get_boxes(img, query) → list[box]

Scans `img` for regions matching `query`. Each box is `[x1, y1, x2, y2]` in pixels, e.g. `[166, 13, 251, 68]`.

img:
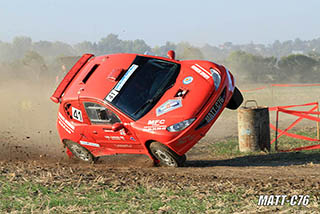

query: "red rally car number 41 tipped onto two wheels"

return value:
[51, 51, 243, 166]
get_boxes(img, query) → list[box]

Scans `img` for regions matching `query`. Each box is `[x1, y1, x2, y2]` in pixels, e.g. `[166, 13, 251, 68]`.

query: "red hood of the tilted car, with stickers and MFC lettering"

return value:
[140, 61, 222, 125]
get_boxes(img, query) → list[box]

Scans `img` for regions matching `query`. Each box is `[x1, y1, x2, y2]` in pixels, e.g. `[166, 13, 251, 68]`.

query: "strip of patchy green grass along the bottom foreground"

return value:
[0, 177, 246, 213]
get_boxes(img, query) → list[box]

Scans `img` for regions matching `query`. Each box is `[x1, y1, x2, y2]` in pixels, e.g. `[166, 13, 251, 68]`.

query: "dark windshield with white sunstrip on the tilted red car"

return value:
[105, 56, 180, 120]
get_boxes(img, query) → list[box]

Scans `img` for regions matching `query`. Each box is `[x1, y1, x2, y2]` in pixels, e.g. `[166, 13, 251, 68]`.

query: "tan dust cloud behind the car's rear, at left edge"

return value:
[0, 76, 64, 159]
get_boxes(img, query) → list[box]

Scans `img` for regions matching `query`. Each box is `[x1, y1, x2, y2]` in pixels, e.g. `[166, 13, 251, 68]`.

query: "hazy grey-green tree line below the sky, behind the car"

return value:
[0, 34, 320, 83]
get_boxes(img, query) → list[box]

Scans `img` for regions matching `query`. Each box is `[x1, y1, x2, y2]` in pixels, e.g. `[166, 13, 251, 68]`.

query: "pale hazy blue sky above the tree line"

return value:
[0, 0, 320, 46]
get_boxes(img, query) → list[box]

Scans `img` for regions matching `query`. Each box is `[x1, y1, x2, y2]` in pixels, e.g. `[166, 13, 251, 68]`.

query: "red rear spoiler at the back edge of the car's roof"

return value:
[50, 54, 94, 103]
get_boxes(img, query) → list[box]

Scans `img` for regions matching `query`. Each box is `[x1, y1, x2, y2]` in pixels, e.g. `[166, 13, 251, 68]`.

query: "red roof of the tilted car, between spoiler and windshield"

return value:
[63, 54, 177, 100]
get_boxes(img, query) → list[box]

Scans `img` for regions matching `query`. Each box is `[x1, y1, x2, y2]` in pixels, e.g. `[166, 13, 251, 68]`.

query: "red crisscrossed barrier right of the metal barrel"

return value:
[269, 102, 320, 152]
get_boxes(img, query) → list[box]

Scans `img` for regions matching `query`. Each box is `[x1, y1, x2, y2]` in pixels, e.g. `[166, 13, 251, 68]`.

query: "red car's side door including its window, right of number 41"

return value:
[83, 101, 142, 153]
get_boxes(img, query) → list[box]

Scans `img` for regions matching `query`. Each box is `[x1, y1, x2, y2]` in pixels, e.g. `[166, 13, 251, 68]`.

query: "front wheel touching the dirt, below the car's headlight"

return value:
[150, 142, 186, 167]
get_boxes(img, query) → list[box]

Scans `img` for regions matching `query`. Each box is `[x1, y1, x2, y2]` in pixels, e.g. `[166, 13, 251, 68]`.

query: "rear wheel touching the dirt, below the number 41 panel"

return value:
[65, 140, 98, 162]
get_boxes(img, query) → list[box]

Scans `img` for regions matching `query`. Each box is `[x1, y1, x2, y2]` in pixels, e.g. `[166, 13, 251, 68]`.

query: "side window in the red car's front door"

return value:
[84, 102, 121, 124]
